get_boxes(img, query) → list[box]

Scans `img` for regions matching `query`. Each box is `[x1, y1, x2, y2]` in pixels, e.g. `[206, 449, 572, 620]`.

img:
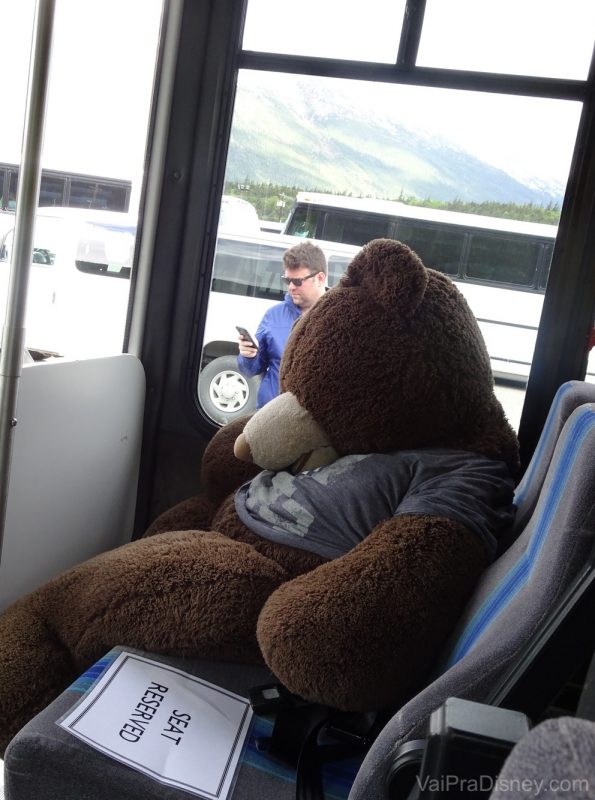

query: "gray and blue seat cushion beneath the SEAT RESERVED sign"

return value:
[4, 648, 359, 800]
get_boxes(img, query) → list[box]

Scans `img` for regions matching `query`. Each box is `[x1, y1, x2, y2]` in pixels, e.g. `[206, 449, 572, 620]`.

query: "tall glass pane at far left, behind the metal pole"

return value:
[0, 0, 164, 359]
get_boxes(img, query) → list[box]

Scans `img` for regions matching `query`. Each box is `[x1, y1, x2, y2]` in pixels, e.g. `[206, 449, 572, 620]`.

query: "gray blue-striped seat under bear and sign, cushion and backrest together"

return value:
[5, 396, 595, 800]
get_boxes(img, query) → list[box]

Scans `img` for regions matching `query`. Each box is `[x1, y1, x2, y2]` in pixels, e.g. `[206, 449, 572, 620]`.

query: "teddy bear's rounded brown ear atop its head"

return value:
[341, 239, 428, 319]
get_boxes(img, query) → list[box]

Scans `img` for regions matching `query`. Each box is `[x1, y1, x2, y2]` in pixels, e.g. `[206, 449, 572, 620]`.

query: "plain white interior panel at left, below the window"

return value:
[0, 354, 145, 609]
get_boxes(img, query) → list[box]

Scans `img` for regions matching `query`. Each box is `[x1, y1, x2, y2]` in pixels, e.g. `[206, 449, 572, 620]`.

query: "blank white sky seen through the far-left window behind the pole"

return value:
[0, 0, 162, 178]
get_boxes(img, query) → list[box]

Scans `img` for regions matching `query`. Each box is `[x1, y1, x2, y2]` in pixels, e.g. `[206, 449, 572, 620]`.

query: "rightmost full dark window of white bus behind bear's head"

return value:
[465, 233, 541, 287]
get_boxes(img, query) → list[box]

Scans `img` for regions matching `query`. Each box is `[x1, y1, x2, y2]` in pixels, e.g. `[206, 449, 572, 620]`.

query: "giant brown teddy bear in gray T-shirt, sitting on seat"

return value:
[0, 239, 518, 749]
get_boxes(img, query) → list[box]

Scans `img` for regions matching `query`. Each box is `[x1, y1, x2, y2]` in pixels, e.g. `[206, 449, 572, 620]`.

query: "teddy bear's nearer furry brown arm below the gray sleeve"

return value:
[257, 515, 486, 711]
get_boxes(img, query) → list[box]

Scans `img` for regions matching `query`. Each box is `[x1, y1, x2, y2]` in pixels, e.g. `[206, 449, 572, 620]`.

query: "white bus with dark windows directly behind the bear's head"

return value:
[285, 192, 557, 382]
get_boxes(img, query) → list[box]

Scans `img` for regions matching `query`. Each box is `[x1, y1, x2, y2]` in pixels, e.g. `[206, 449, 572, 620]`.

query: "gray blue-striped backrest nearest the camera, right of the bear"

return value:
[349, 398, 595, 800]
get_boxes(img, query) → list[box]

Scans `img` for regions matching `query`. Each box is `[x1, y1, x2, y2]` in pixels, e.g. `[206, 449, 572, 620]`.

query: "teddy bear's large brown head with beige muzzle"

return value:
[236, 239, 518, 470]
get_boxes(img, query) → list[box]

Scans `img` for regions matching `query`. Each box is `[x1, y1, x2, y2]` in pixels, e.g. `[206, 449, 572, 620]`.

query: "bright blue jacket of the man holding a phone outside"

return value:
[238, 292, 301, 408]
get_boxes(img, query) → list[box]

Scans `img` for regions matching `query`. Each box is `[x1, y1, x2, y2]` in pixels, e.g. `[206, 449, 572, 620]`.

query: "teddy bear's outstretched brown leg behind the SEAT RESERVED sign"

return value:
[0, 531, 287, 749]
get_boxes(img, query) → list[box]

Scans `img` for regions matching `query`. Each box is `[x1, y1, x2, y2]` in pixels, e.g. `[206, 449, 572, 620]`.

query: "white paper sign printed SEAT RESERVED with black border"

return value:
[58, 652, 252, 800]
